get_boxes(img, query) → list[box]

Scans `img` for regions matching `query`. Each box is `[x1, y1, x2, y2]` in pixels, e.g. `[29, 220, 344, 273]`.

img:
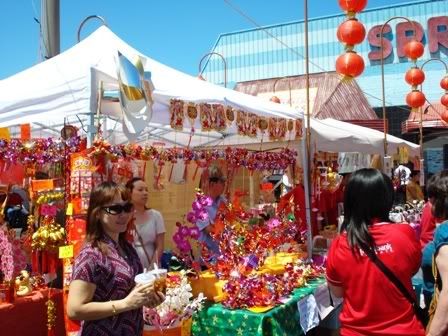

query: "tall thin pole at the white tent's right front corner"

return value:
[303, 0, 313, 261]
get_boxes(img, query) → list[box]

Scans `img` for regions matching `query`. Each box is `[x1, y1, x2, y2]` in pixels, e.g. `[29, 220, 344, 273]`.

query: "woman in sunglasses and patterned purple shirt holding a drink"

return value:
[67, 182, 164, 336]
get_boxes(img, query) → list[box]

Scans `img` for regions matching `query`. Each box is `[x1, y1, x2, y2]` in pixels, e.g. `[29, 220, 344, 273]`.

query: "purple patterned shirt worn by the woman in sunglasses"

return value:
[72, 235, 143, 336]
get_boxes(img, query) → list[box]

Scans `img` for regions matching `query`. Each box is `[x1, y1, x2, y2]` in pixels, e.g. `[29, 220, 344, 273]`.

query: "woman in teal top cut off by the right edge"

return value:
[423, 170, 448, 336]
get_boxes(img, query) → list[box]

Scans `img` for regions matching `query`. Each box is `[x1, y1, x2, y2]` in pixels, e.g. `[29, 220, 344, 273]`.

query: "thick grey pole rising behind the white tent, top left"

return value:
[40, 0, 60, 59]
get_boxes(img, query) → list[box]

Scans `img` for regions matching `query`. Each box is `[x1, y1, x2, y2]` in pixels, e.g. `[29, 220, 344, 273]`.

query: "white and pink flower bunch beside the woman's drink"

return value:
[143, 271, 205, 330]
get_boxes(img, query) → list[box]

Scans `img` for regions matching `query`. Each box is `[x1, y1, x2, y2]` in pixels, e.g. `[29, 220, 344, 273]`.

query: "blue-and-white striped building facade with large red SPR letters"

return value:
[203, 0, 448, 115]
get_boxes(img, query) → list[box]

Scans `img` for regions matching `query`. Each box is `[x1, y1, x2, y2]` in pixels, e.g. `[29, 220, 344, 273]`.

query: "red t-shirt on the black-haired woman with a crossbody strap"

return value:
[327, 223, 425, 336]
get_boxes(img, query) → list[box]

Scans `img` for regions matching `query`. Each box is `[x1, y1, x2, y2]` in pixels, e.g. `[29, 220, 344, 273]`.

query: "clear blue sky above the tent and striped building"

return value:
[0, 0, 409, 79]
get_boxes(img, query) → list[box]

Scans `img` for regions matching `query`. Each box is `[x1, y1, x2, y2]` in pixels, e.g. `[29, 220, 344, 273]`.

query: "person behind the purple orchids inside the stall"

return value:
[196, 166, 227, 256]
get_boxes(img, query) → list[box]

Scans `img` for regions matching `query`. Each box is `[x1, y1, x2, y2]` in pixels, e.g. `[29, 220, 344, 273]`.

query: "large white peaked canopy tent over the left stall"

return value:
[0, 26, 303, 146]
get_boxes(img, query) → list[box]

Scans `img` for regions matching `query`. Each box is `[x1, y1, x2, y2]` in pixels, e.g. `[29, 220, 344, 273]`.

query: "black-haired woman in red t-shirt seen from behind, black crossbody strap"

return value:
[327, 168, 424, 336]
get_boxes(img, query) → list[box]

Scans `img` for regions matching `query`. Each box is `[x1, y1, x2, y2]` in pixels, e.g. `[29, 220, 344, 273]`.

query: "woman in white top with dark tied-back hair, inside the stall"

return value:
[126, 177, 165, 269]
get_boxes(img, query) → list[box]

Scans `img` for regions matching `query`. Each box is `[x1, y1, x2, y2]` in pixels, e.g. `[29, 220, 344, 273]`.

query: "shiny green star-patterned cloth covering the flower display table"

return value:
[192, 279, 325, 336]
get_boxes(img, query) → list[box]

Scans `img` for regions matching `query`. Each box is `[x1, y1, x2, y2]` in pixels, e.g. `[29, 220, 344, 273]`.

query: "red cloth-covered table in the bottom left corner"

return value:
[0, 289, 65, 336]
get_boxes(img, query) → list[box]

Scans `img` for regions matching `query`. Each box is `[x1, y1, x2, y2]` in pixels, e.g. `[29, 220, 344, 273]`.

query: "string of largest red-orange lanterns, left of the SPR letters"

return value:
[336, 0, 367, 80]
